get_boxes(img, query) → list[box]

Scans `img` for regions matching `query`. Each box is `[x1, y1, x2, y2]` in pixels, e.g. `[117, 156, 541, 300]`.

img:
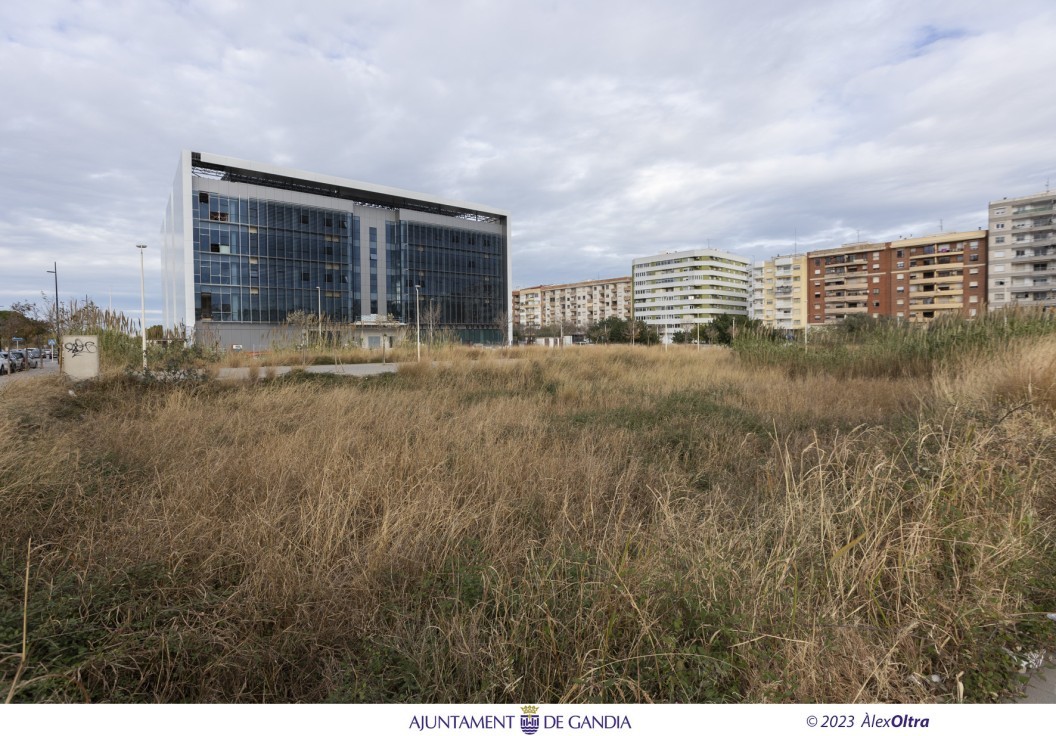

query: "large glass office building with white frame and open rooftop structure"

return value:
[162, 151, 511, 350]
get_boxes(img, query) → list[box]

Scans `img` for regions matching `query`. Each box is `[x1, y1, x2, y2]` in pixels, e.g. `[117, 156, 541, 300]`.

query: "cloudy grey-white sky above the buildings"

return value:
[0, 0, 1056, 323]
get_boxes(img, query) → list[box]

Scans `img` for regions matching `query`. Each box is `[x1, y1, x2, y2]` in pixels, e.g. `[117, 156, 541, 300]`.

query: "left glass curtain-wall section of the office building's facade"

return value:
[191, 190, 359, 322]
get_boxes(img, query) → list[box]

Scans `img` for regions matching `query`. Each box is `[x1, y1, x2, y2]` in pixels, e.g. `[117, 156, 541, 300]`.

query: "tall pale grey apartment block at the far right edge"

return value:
[987, 192, 1056, 309]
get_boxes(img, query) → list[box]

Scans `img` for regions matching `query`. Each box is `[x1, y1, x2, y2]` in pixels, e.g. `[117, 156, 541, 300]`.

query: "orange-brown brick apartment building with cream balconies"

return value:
[807, 230, 987, 326]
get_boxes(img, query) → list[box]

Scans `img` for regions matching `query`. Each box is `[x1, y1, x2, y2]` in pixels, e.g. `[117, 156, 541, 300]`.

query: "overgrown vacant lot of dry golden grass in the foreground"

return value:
[0, 338, 1056, 702]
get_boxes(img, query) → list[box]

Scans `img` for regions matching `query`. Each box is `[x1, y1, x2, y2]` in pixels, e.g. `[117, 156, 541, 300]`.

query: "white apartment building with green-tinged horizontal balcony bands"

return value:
[631, 248, 752, 340]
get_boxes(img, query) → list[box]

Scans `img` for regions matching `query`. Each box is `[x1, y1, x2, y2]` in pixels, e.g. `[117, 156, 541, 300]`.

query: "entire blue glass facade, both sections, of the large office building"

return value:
[191, 189, 508, 342]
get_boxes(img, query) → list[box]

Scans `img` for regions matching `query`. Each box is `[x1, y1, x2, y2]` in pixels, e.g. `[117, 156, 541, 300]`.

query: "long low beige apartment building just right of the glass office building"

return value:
[513, 276, 631, 332]
